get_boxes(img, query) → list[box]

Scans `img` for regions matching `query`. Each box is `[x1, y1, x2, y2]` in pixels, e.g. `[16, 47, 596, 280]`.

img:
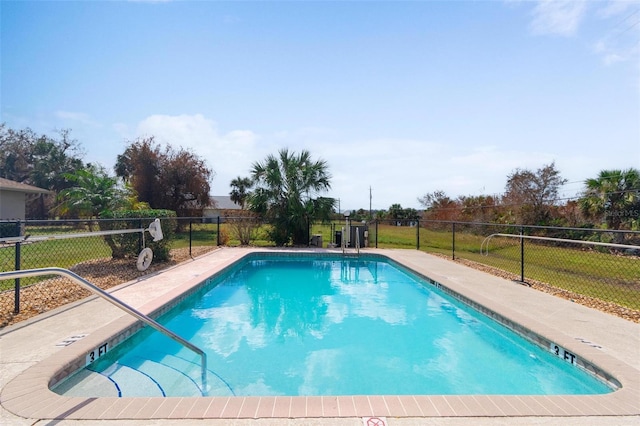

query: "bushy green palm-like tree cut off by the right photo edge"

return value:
[580, 168, 640, 233]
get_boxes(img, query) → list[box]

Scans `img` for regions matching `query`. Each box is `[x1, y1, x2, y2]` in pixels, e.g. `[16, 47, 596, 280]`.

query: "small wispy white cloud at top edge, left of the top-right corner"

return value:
[531, 0, 587, 36]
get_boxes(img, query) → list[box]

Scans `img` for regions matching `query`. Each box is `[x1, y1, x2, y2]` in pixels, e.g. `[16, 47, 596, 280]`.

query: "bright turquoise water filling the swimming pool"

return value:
[54, 256, 611, 396]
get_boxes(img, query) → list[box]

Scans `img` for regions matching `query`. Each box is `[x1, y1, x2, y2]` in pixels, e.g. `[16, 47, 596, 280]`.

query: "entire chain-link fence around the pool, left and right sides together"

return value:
[0, 217, 640, 328]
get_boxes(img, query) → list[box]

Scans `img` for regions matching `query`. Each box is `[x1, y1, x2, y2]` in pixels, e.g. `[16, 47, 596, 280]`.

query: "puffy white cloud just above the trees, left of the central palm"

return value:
[136, 114, 263, 195]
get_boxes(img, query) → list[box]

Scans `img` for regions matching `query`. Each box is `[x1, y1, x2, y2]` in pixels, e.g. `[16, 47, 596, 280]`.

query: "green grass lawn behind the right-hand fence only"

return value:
[378, 225, 640, 310]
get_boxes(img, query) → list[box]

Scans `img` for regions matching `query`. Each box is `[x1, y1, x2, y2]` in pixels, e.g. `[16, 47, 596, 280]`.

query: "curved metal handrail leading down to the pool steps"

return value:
[0, 267, 207, 392]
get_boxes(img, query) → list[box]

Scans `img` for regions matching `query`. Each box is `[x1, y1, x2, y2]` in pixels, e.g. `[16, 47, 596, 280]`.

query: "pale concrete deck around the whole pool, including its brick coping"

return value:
[0, 248, 640, 426]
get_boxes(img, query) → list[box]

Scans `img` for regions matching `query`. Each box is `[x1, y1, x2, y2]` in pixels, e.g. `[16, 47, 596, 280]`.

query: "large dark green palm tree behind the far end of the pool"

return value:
[249, 148, 335, 246]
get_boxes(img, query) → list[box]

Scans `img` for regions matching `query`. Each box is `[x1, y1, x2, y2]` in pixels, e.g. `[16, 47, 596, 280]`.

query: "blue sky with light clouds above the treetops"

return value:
[0, 0, 640, 209]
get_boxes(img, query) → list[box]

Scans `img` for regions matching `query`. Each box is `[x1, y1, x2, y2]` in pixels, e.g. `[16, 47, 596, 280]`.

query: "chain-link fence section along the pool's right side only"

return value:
[370, 221, 640, 322]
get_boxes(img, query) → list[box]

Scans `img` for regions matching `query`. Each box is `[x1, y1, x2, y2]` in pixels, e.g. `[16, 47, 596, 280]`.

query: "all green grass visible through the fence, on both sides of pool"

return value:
[0, 222, 640, 310]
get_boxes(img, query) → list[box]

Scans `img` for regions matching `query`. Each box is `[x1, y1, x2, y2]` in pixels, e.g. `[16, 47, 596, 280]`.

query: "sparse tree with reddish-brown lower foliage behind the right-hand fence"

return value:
[504, 163, 567, 225]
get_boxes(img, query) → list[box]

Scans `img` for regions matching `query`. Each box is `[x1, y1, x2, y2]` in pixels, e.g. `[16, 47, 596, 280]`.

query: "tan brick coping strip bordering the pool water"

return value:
[0, 249, 640, 420]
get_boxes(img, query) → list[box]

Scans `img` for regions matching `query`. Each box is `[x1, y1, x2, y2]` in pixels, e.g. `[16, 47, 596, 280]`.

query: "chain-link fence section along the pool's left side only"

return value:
[0, 218, 220, 328]
